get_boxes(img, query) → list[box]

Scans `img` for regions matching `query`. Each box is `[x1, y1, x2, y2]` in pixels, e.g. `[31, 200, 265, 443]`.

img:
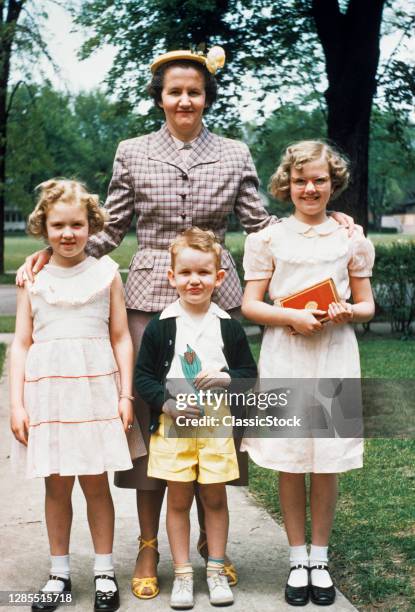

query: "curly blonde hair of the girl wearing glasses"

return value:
[268, 140, 350, 202]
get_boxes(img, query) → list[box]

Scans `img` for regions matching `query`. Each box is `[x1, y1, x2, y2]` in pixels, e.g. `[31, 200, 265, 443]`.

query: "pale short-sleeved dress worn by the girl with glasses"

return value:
[241, 216, 374, 473]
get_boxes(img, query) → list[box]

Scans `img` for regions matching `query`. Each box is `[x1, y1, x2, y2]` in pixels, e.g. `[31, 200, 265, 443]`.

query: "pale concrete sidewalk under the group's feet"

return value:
[0, 344, 356, 612]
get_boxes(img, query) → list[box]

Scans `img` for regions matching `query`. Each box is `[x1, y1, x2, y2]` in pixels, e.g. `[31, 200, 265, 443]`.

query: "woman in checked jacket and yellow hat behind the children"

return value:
[18, 47, 353, 599]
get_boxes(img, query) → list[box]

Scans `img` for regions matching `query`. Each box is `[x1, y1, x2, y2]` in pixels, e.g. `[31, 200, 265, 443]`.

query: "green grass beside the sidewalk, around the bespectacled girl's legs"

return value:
[250, 337, 415, 612]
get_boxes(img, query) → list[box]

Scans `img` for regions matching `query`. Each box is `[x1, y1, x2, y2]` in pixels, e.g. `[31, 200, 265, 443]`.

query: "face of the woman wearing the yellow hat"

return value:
[160, 66, 210, 140]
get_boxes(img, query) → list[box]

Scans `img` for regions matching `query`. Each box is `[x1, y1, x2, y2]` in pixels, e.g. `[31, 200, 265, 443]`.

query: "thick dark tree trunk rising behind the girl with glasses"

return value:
[312, 0, 385, 231]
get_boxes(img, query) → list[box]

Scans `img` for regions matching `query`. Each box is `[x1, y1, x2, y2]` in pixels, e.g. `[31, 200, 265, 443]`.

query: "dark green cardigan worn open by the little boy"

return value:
[134, 314, 257, 432]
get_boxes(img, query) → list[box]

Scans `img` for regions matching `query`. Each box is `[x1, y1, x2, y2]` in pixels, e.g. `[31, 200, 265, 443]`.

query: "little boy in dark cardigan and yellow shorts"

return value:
[135, 227, 257, 609]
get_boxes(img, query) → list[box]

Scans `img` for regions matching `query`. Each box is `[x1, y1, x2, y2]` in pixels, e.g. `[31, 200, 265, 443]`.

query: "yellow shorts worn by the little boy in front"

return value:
[147, 414, 239, 484]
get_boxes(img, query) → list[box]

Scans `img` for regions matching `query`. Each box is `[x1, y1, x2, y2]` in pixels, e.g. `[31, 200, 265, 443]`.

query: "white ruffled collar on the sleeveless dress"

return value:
[29, 255, 118, 306]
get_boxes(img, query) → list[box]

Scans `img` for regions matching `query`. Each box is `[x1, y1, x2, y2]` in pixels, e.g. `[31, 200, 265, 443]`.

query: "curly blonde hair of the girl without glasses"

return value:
[27, 178, 107, 238]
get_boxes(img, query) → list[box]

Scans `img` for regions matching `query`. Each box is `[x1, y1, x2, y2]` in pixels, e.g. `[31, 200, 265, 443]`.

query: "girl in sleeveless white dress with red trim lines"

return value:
[10, 179, 141, 611]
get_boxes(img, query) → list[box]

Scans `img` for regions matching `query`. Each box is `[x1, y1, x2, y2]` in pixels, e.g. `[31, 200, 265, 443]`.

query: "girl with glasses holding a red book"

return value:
[241, 141, 374, 606]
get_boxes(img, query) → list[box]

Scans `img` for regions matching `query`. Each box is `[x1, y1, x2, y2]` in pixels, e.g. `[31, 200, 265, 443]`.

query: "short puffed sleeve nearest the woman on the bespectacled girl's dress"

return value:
[243, 227, 274, 280]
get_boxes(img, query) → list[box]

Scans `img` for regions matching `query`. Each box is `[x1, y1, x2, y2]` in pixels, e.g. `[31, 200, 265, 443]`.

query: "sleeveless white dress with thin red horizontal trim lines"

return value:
[19, 256, 132, 478]
